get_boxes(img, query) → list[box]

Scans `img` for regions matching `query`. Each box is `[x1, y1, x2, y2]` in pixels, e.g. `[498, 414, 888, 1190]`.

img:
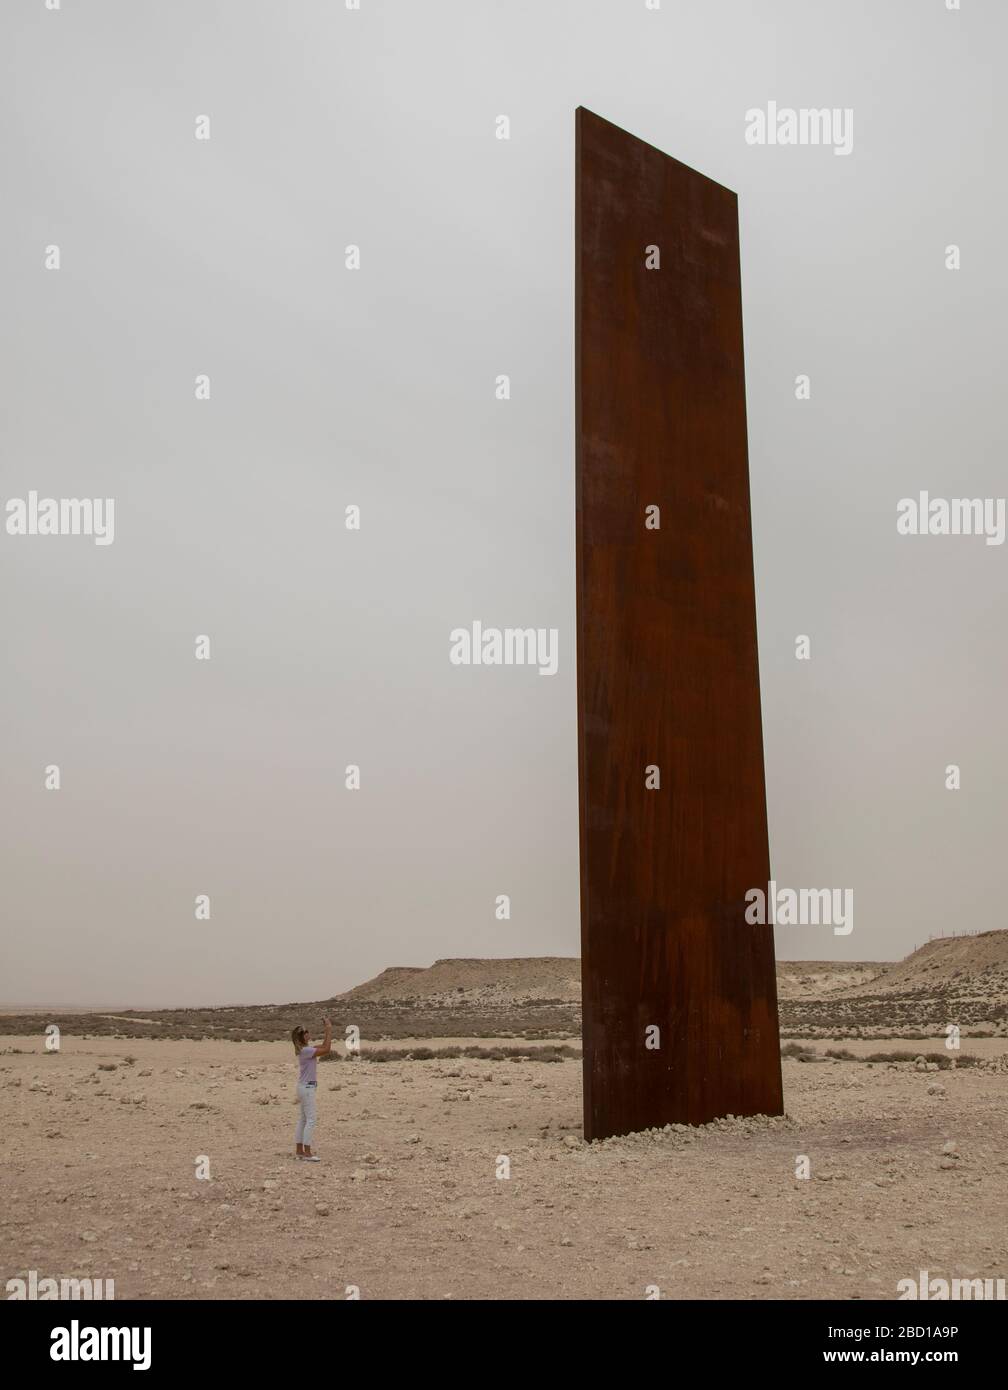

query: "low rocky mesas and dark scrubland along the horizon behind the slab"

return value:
[0, 929, 1008, 1040]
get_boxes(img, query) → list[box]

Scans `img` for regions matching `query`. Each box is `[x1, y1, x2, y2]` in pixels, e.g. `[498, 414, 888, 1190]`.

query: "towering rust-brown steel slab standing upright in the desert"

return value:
[576, 108, 783, 1138]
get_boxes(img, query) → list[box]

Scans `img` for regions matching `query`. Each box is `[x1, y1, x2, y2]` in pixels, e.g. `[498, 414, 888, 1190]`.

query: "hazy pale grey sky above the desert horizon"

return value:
[0, 0, 1008, 1006]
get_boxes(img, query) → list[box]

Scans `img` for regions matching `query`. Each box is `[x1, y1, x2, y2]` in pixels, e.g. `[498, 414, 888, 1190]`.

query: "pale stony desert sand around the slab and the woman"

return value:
[0, 1033, 1008, 1298]
